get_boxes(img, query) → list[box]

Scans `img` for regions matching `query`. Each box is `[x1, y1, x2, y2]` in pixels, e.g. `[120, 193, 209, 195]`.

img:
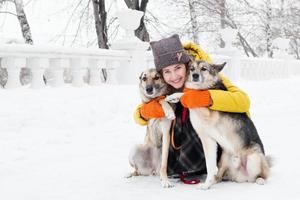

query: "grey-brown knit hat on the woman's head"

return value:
[150, 34, 190, 71]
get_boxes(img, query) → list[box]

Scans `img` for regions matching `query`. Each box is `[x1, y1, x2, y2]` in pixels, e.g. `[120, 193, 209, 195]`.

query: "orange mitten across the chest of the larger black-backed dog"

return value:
[180, 88, 211, 108]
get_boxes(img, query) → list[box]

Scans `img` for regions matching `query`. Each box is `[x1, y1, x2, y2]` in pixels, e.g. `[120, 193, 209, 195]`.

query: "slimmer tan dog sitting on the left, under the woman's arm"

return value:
[128, 69, 175, 187]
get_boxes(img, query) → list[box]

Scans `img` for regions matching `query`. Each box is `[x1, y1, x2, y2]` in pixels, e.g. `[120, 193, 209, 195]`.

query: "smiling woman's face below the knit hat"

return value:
[162, 64, 186, 89]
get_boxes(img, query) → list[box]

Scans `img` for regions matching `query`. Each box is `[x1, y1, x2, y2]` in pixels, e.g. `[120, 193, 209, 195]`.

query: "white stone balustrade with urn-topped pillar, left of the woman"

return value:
[0, 9, 151, 88]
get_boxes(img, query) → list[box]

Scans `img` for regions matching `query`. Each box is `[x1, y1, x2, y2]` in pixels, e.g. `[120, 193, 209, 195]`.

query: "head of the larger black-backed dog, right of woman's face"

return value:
[185, 60, 226, 90]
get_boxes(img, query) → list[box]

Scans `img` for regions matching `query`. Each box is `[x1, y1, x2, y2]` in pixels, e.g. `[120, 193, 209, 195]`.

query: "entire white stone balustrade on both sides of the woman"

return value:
[0, 13, 300, 88]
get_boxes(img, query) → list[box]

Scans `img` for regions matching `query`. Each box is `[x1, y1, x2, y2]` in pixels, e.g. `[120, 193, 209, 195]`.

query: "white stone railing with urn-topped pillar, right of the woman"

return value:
[212, 28, 300, 80]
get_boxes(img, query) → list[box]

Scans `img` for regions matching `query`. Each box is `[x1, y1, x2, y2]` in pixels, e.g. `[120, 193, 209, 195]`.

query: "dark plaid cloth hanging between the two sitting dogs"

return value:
[168, 103, 221, 176]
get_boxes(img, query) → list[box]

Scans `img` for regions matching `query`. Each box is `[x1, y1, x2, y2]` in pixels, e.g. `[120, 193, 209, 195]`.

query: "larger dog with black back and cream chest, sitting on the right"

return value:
[167, 61, 269, 189]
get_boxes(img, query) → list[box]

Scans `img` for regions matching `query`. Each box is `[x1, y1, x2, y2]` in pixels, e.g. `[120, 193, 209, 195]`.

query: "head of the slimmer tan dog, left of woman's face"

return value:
[139, 69, 167, 102]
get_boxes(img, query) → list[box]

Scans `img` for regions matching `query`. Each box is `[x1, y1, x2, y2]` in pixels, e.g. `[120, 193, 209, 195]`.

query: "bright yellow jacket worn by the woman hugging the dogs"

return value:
[134, 42, 250, 125]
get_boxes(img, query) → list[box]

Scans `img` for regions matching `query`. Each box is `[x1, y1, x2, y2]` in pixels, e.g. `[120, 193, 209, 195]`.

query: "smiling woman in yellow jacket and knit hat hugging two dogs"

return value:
[135, 34, 250, 180]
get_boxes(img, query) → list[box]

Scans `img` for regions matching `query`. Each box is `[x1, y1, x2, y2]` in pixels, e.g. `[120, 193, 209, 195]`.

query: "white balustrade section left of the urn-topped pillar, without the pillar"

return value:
[0, 44, 131, 88]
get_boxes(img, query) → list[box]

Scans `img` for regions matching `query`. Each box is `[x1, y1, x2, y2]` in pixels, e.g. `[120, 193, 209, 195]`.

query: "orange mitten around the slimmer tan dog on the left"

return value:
[140, 96, 165, 120]
